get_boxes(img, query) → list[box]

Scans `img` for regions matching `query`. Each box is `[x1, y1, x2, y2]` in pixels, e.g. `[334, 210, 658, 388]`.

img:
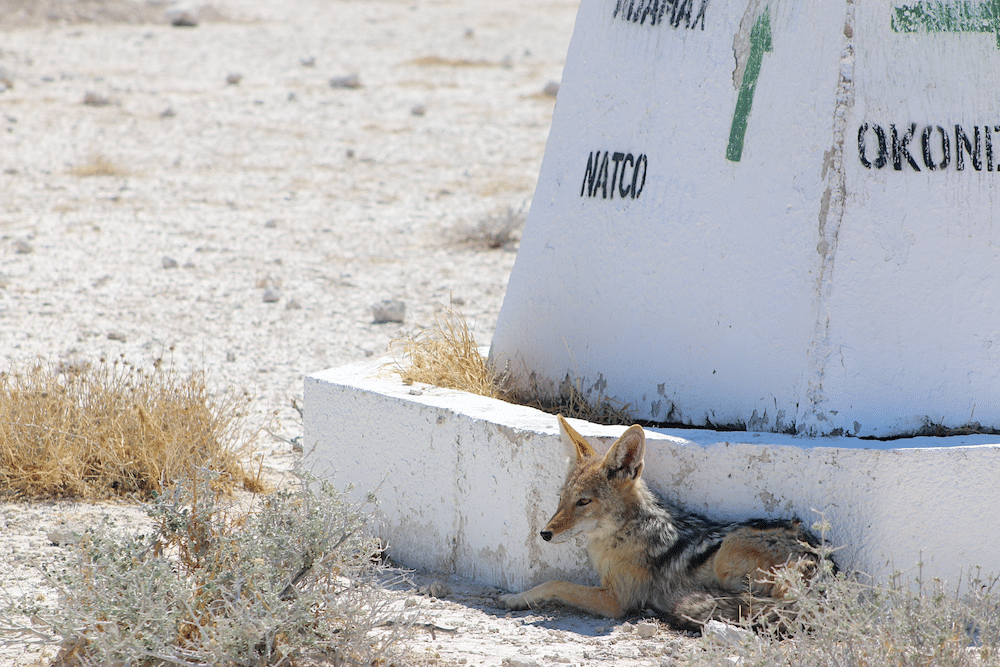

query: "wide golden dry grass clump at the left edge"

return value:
[0, 359, 264, 499]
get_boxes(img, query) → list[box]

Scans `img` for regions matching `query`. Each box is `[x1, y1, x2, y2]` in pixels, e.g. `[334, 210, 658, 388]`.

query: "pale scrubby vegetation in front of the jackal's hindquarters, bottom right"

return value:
[690, 556, 1000, 667]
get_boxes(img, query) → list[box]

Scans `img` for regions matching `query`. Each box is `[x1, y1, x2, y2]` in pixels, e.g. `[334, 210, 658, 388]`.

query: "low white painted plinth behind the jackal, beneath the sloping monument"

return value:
[305, 359, 1000, 590]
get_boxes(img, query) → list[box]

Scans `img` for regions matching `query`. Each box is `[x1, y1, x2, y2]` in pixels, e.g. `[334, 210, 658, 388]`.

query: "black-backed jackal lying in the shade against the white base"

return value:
[500, 415, 833, 630]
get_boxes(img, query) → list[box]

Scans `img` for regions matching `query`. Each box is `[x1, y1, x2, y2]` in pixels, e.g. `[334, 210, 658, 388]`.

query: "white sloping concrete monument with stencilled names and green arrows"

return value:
[491, 0, 1000, 436]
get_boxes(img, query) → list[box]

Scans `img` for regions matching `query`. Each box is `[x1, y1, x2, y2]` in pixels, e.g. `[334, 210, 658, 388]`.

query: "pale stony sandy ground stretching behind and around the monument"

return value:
[0, 0, 704, 665]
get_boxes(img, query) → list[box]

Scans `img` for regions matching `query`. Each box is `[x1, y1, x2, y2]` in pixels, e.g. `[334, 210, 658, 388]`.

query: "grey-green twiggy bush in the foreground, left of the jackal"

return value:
[4, 472, 408, 667]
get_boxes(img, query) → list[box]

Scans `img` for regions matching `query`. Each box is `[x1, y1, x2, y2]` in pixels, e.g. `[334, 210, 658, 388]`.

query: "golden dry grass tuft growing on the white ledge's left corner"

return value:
[391, 310, 509, 400]
